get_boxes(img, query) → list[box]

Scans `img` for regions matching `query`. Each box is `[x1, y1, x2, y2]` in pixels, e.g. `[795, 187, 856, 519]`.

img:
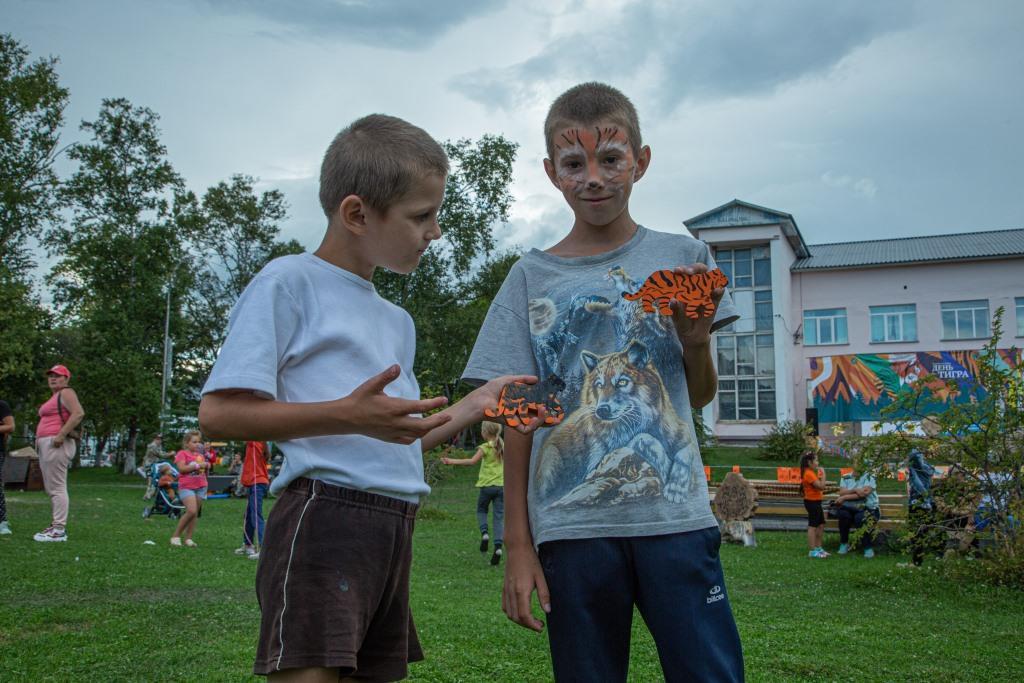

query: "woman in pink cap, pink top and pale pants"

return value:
[33, 366, 85, 543]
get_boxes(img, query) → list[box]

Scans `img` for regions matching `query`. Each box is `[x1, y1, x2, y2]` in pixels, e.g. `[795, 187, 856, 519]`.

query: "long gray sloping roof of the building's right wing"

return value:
[791, 228, 1024, 272]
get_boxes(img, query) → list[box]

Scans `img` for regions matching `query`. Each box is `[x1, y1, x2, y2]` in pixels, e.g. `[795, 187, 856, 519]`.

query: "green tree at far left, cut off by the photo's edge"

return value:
[0, 34, 68, 272]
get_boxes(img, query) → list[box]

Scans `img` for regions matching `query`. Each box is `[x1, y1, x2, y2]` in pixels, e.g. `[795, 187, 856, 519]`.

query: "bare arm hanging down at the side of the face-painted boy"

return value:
[502, 429, 551, 632]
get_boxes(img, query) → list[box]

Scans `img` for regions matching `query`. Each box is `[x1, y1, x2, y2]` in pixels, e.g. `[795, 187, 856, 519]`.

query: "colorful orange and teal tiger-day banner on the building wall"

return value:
[807, 349, 1021, 422]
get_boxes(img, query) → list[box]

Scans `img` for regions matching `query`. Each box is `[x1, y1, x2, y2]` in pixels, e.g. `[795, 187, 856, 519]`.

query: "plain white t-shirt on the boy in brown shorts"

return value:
[203, 254, 430, 502]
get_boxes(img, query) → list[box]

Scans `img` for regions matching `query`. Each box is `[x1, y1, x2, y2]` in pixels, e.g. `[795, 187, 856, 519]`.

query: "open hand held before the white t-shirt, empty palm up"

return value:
[339, 366, 452, 445]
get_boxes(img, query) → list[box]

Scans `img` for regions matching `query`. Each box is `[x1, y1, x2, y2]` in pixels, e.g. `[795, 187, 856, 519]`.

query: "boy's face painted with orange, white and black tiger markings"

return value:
[545, 123, 650, 226]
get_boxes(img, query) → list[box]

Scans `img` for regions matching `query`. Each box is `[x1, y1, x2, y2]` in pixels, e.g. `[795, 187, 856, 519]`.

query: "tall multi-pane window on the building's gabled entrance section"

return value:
[715, 245, 775, 420]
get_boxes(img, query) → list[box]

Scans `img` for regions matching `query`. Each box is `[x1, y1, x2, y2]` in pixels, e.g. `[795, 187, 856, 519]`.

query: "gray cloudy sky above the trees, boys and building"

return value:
[8, 0, 1024, 260]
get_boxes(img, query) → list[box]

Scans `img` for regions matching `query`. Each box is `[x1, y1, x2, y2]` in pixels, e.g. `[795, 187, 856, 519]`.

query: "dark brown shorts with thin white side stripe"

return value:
[253, 478, 423, 681]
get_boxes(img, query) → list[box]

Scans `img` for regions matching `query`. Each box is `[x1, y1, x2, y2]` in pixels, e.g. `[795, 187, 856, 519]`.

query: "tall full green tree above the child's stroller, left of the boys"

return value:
[48, 99, 191, 469]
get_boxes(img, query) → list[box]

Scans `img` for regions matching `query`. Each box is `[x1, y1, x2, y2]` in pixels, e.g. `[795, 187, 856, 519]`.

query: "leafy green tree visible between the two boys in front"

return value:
[374, 135, 518, 396]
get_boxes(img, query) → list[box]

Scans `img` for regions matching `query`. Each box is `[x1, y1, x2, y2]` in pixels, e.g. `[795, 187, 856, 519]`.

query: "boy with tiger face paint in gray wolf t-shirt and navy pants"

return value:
[463, 83, 743, 682]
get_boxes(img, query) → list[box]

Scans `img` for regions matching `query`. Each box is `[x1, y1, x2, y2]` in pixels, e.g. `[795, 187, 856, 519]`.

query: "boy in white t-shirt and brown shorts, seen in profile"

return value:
[200, 115, 541, 681]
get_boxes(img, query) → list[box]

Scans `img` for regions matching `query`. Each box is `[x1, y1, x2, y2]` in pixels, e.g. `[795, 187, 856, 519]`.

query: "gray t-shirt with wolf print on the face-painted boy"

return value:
[463, 226, 738, 545]
